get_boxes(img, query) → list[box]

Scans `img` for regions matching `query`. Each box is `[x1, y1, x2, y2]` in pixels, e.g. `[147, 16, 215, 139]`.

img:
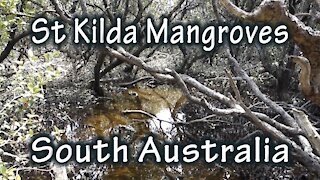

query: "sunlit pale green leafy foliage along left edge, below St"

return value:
[0, 50, 62, 179]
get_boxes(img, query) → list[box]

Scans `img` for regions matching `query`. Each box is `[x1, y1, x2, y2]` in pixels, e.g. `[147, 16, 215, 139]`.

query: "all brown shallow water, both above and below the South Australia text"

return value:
[66, 86, 308, 179]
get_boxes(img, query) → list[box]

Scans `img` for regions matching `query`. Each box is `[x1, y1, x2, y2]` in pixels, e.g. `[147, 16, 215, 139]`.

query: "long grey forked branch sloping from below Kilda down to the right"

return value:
[106, 48, 301, 135]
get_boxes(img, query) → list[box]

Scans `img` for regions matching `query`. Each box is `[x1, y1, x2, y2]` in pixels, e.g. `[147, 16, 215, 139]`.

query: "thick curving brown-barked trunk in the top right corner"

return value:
[220, 0, 320, 106]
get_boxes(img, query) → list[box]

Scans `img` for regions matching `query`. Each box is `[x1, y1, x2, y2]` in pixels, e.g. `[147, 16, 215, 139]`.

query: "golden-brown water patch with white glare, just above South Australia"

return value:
[84, 86, 185, 138]
